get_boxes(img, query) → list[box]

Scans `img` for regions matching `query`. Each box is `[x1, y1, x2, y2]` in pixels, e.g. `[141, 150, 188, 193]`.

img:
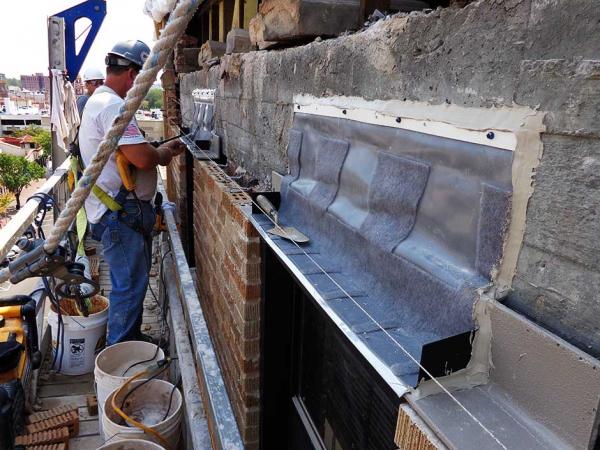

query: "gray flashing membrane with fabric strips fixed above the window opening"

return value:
[253, 113, 513, 387]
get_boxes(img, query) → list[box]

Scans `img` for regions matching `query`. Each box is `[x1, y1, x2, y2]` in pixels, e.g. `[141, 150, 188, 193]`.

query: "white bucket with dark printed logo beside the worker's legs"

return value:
[48, 295, 108, 375]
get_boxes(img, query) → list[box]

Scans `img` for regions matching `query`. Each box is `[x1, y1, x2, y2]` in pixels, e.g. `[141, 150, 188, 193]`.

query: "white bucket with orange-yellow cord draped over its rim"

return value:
[102, 380, 183, 449]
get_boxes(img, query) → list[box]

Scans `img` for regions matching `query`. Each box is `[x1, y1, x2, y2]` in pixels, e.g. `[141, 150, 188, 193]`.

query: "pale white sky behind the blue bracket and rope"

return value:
[0, 0, 154, 78]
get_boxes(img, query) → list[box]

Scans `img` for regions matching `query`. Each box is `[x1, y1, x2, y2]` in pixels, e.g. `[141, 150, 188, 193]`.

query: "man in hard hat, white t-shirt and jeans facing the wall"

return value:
[79, 41, 185, 345]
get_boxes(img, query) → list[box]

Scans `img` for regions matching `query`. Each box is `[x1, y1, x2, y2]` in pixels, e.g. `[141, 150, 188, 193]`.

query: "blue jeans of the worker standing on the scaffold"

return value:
[91, 200, 155, 345]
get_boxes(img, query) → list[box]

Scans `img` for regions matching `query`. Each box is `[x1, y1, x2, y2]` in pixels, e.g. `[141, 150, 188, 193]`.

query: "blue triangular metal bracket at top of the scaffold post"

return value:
[54, 0, 106, 81]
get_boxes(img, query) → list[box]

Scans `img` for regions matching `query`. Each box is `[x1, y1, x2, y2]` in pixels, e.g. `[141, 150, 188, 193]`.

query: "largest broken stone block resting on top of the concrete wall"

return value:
[249, 0, 362, 44]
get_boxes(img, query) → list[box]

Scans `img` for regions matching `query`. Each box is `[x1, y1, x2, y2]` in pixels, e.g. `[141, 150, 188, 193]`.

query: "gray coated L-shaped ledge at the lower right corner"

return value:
[407, 302, 600, 449]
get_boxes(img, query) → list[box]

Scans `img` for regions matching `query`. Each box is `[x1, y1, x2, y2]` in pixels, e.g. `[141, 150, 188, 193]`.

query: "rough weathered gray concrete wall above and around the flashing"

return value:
[180, 0, 600, 356]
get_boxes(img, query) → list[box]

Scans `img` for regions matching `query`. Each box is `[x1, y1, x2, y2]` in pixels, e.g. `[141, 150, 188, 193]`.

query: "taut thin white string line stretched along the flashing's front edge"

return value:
[175, 125, 507, 450]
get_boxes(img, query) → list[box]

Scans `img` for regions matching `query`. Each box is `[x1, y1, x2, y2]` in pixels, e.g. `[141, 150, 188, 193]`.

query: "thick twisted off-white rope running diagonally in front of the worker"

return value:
[0, 0, 201, 283]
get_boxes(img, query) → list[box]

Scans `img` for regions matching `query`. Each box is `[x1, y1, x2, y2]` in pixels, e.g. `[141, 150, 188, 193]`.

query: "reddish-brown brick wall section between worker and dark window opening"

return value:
[193, 161, 261, 449]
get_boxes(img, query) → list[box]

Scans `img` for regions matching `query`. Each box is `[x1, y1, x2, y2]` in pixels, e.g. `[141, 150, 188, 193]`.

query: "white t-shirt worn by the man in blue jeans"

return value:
[79, 85, 157, 223]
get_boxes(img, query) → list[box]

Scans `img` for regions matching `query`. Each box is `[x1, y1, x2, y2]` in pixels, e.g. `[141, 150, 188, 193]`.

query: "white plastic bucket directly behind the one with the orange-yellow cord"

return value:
[94, 341, 165, 431]
